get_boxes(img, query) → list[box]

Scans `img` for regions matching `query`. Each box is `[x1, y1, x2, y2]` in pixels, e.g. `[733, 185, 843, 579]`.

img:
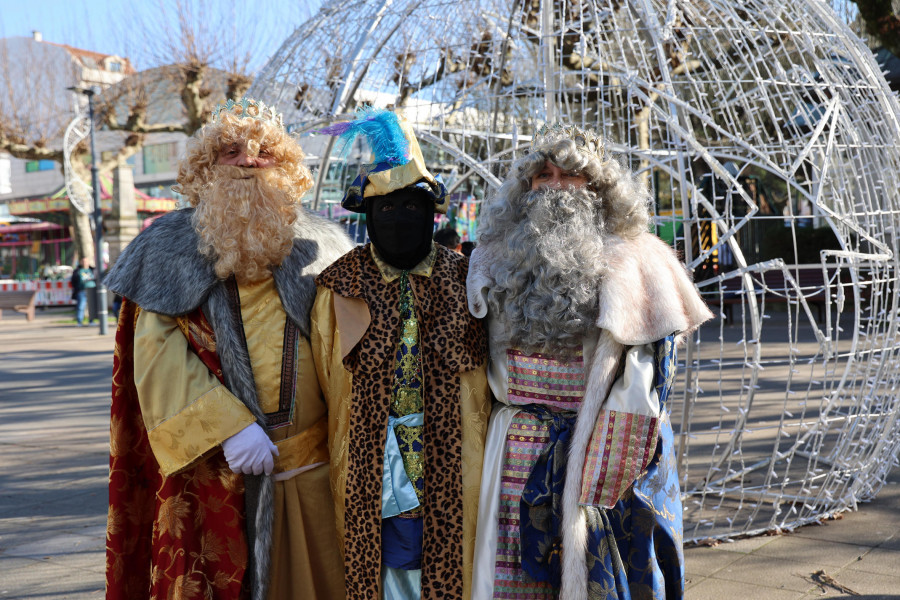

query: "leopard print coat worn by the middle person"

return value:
[316, 246, 487, 599]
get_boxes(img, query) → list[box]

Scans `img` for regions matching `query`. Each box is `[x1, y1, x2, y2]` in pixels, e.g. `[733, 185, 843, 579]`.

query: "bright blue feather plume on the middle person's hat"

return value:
[317, 106, 409, 166]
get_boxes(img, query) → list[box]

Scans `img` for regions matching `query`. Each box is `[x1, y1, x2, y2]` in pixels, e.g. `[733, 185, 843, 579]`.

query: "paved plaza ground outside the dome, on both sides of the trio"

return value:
[0, 309, 900, 600]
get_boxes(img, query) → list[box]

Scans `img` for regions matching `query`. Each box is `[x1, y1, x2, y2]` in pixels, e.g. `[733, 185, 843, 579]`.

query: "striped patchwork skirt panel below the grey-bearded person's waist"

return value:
[494, 412, 556, 600]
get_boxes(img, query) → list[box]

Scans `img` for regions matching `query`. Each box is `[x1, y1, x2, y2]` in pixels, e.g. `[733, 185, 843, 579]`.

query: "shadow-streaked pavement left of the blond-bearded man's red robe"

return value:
[0, 309, 115, 600]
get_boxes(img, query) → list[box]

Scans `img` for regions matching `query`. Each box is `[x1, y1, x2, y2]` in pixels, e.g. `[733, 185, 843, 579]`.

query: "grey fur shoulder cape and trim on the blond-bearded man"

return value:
[106, 209, 352, 600]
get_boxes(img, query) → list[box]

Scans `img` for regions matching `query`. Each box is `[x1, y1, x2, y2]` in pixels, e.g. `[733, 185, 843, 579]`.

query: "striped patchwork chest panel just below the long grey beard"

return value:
[506, 348, 585, 410]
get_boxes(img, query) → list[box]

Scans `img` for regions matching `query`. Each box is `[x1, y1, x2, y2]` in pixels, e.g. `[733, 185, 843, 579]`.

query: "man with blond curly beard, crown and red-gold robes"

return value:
[106, 98, 351, 600]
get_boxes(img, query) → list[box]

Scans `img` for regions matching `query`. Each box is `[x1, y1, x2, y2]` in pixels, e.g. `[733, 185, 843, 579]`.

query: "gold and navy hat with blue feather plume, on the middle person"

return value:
[318, 106, 447, 214]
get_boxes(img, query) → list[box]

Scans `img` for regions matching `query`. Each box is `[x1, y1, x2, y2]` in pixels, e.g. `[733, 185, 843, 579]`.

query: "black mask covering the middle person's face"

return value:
[366, 188, 434, 269]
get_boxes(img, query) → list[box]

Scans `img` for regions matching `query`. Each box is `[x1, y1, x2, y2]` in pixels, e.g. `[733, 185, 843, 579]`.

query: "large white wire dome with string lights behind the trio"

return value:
[250, 0, 900, 541]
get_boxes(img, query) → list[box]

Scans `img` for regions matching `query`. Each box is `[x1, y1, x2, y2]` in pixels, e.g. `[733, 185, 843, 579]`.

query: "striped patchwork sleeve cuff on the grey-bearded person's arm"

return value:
[579, 410, 659, 508]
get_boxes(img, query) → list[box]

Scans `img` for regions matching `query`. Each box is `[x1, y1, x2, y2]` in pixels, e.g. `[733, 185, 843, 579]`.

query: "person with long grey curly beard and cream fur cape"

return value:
[467, 126, 711, 600]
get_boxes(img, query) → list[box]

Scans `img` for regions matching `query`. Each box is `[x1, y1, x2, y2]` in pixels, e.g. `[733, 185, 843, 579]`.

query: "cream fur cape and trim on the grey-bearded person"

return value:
[466, 233, 713, 600]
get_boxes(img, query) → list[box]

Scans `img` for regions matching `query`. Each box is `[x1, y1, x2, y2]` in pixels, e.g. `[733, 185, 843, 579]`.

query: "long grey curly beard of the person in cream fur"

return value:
[480, 188, 606, 355]
